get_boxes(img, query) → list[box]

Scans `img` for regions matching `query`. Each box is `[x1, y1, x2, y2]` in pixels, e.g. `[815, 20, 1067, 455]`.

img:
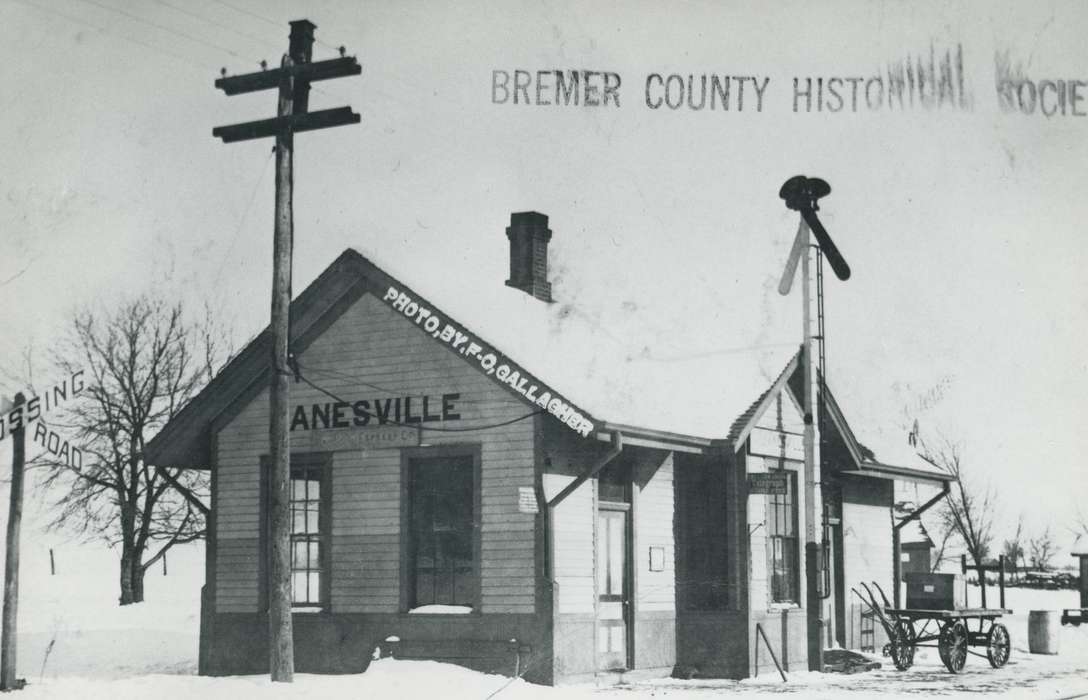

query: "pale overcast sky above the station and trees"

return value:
[0, 0, 1088, 553]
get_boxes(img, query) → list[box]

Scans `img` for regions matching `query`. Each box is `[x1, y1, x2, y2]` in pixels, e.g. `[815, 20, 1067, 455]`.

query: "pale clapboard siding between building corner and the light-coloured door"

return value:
[544, 474, 597, 614]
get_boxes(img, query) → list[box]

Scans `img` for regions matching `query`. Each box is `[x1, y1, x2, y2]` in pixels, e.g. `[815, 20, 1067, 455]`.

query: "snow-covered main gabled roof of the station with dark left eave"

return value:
[145, 248, 795, 467]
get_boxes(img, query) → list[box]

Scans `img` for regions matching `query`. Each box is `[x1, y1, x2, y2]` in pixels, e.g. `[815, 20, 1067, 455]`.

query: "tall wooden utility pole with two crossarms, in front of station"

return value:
[212, 20, 362, 683]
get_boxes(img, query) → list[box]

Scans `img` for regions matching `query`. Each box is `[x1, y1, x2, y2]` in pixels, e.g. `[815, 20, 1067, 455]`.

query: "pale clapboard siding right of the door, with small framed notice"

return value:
[634, 452, 676, 612]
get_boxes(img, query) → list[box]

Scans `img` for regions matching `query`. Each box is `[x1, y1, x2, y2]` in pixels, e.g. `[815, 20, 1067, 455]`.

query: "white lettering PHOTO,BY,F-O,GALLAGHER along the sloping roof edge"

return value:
[381, 286, 594, 438]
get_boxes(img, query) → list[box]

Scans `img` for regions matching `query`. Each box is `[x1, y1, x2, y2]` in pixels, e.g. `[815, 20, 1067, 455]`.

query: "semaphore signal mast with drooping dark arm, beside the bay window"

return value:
[778, 175, 850, 671]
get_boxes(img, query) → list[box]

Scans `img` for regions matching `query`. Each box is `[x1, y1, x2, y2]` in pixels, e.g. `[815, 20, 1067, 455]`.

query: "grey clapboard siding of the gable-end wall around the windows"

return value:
[217, 294, 535, 613]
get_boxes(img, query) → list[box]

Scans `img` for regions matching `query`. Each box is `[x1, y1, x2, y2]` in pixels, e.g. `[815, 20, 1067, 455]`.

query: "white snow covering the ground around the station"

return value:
[2, 544, 1088, 700]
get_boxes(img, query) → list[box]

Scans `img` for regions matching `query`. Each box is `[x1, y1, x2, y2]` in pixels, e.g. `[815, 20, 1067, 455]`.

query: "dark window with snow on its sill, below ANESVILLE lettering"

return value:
[406, 453, 478, 609]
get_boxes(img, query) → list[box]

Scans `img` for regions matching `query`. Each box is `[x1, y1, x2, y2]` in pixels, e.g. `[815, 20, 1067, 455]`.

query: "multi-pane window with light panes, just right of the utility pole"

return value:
[290, 464, 330, 605]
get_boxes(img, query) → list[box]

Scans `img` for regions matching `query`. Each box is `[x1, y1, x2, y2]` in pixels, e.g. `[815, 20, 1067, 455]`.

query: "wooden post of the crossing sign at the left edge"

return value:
[0, 392, 26, 690]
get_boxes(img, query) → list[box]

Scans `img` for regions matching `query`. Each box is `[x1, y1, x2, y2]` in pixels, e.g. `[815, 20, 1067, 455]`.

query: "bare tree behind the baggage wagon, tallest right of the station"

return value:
[918, 438, 997, 566]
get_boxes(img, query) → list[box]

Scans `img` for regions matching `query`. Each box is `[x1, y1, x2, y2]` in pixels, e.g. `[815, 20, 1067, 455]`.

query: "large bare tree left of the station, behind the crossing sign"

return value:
[39, 295, 224, 605]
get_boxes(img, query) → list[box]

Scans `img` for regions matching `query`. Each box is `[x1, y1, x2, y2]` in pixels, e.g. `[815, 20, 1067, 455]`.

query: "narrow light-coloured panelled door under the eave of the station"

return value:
[597, 504, 631, 671]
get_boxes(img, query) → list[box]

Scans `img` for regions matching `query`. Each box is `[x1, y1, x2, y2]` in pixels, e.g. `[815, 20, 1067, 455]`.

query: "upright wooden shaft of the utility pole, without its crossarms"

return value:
[269, 54, 295, 683]
